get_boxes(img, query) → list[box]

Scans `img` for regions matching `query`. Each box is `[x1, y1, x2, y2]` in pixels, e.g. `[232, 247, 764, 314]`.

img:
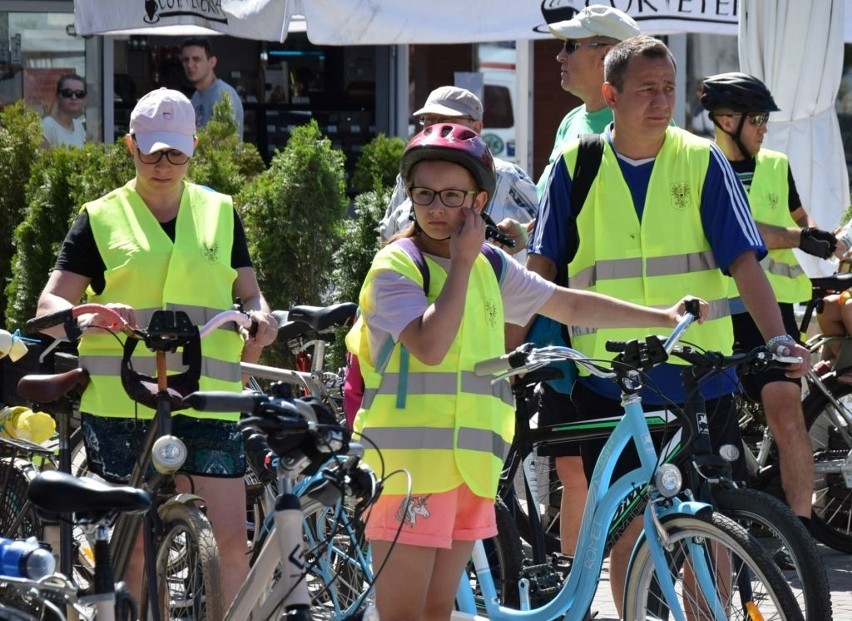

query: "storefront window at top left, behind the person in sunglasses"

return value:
[0, 6, 102, 140]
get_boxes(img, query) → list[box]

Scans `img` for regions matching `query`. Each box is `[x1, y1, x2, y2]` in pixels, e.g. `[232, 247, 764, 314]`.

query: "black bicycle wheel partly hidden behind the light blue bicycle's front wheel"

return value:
[713, 488, 832, 620]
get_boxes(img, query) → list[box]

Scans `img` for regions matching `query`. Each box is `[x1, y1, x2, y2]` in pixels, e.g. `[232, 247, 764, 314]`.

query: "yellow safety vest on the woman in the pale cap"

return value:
[79, 183, 243, 420]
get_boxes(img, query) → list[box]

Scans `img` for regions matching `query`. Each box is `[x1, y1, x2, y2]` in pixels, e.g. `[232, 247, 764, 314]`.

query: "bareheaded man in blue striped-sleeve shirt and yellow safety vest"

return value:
[530, 35, 810, 608]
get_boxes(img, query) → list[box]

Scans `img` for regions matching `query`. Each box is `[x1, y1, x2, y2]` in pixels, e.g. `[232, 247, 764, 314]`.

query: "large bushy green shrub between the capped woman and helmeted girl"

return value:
[236, 120, 348, 366]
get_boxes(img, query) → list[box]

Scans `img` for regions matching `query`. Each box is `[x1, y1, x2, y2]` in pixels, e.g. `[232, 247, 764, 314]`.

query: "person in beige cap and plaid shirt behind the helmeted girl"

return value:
[379, 86, 538, 262]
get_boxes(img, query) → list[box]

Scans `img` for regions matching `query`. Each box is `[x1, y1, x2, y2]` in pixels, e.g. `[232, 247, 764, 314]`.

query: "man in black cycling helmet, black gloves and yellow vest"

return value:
[699, 72, 837, 524]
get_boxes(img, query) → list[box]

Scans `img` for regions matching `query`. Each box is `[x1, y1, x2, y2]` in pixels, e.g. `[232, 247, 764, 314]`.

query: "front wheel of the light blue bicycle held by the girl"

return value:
[624, 512, 803, 621]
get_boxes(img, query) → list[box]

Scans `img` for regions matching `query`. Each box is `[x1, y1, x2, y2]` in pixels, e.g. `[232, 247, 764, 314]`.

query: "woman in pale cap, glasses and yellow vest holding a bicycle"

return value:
[38, 88, 276, 601]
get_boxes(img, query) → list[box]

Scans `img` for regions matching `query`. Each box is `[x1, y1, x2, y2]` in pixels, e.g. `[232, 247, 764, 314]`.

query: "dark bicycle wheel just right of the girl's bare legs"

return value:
[465, 498, 524, 613]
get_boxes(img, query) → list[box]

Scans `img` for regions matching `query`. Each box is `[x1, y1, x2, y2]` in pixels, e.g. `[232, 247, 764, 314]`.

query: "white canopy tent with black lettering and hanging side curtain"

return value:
[74, 0, 852, 240]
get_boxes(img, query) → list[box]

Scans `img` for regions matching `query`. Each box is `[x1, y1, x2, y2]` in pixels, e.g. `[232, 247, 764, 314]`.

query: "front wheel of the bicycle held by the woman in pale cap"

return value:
[142, 503, 225, 621]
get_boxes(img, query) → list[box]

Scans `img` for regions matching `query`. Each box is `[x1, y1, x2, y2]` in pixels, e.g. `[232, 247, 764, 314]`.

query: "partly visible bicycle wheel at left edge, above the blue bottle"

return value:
[0, 457, 44, 539]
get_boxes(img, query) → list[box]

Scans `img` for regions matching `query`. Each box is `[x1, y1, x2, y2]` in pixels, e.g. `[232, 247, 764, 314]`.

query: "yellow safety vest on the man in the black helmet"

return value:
[730, 149, 811, 304]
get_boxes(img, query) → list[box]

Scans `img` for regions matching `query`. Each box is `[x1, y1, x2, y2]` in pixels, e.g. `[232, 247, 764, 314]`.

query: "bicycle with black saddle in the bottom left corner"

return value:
[0, 470, 151, 621]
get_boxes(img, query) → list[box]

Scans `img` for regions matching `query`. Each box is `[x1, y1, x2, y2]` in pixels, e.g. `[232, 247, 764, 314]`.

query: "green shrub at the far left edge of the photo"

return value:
[0, 100, 43, 325]
